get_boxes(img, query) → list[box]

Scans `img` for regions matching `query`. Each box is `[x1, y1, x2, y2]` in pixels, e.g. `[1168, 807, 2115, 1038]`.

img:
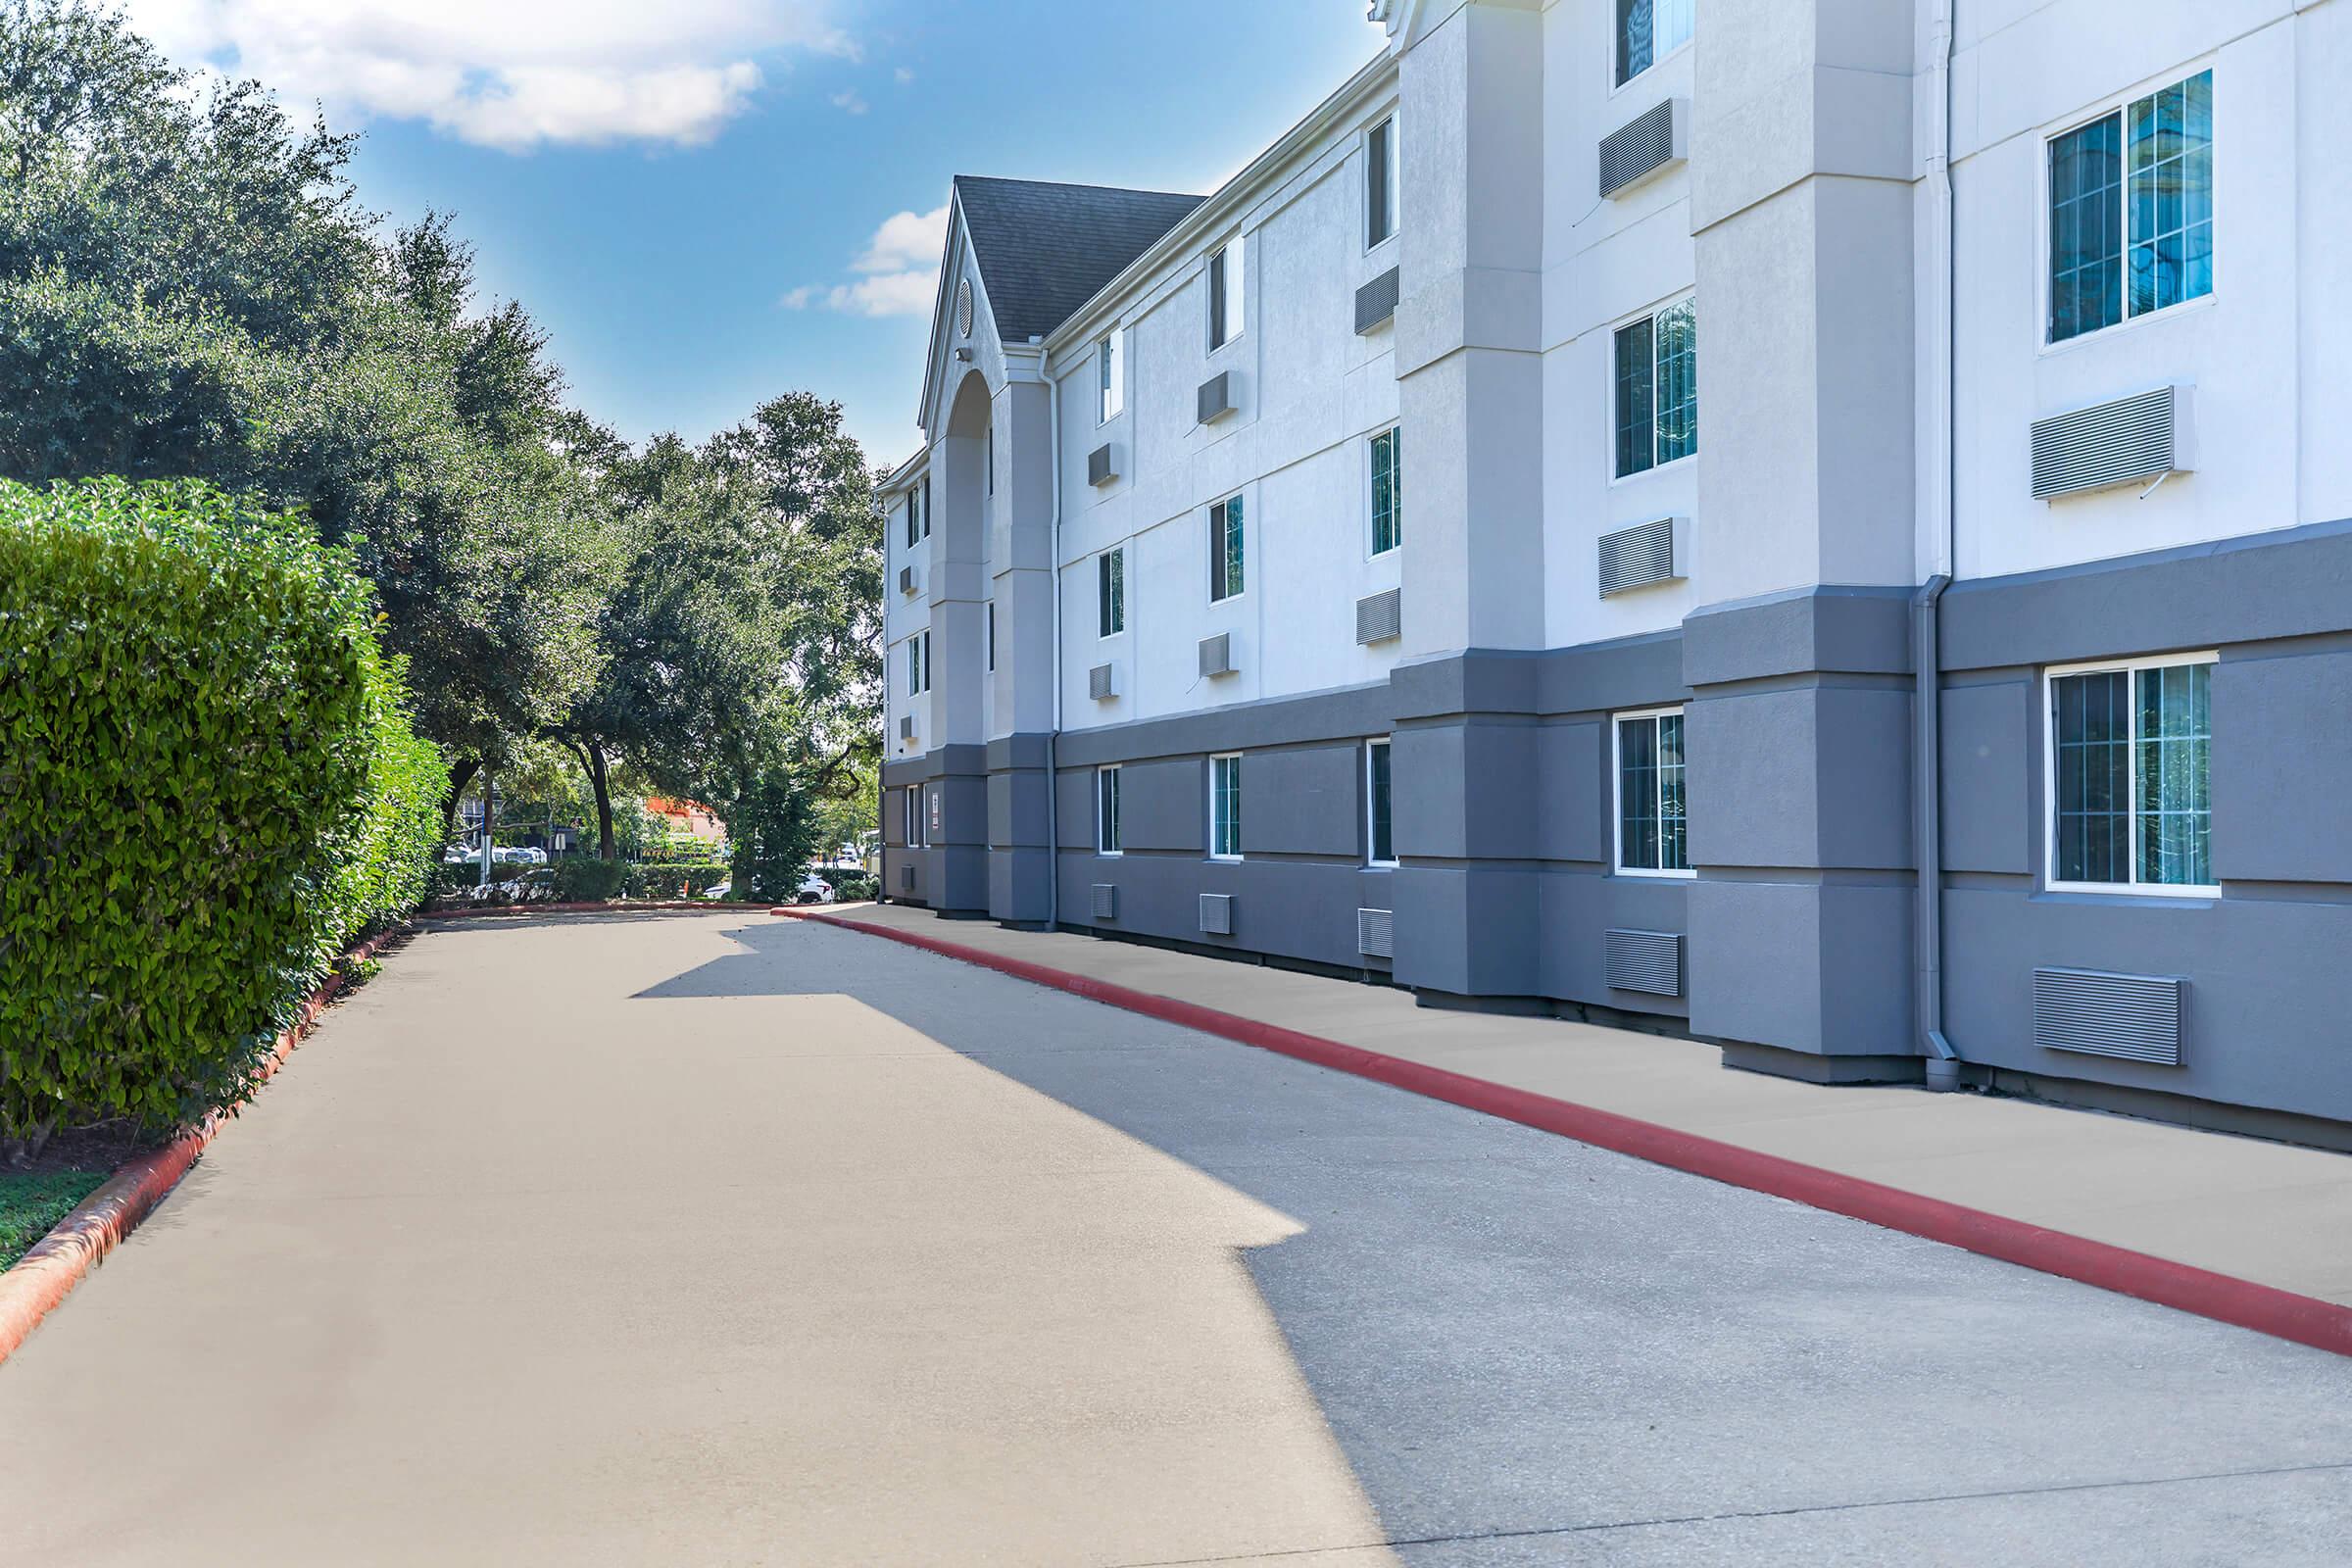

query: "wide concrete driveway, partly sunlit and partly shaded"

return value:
[0, 914, 2352, 1568]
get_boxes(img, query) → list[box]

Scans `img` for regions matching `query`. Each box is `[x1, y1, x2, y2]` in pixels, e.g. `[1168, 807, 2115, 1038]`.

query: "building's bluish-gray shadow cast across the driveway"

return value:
[640, 919, 2352, 1568]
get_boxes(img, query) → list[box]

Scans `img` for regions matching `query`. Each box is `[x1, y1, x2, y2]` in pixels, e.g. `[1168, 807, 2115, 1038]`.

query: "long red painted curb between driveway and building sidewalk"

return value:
[769, 906, 2352, 1356]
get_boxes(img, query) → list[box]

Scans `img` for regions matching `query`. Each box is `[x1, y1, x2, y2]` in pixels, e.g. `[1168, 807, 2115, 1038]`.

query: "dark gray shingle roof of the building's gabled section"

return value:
[955, 174, 1204, 343]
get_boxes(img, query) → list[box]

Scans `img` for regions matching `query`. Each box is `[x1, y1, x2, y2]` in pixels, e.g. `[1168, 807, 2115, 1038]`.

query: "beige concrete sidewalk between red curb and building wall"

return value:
[825, 906, 2352, 1304]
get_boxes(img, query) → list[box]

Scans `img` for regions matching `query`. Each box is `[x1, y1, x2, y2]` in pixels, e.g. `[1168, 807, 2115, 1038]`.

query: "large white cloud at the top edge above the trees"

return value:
[127, 0, 857, 151]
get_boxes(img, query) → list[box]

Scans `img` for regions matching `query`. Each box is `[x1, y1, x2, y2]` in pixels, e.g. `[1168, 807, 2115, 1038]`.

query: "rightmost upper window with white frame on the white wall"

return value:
[2048, 71, 2213, 343]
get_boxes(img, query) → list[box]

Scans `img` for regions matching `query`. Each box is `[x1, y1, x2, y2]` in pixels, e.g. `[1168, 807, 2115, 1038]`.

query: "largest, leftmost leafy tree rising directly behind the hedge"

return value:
[0, 0, 607, 780]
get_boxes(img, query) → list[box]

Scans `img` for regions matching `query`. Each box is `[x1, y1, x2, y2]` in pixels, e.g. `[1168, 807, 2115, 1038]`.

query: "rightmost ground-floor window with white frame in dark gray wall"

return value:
[2048, 654, 2218, 894]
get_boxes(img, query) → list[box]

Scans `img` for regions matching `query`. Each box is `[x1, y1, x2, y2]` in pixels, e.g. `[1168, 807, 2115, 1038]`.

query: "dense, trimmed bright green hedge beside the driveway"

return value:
[0, 479, 447, 1140]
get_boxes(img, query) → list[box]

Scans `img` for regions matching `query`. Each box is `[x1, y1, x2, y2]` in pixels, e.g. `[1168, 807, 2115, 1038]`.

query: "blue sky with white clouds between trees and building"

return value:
[129, 0, 1378, 461]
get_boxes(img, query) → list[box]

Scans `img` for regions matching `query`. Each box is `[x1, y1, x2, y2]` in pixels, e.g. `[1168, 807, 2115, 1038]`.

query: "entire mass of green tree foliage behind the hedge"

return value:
[0, 0, 882, 854]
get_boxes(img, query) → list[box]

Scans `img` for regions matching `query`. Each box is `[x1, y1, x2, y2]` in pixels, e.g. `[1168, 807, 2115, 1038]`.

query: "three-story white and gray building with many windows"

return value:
[882, 0, 2352, 1143]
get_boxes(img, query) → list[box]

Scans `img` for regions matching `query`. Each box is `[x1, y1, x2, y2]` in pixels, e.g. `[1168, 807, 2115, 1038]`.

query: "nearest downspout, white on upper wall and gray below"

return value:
[1912, 0, 1959, 1089]
